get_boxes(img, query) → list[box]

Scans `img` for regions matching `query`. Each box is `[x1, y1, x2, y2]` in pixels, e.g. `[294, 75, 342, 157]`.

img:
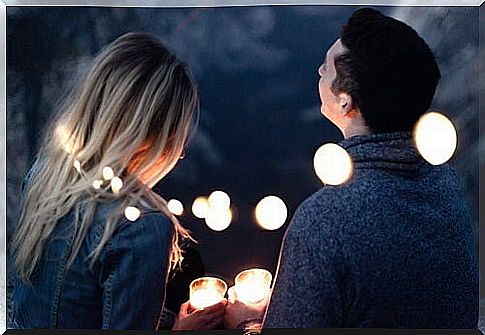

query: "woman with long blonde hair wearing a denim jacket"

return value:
[12, 33, 226, 329]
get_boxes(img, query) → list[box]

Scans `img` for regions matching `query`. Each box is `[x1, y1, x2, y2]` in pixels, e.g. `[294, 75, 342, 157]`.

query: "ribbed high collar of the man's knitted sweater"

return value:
[339, 132, 425, 172]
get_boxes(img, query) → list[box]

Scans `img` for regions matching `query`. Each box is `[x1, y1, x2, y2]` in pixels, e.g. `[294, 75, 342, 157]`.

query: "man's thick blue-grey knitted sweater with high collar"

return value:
[263, 133, 478, 328]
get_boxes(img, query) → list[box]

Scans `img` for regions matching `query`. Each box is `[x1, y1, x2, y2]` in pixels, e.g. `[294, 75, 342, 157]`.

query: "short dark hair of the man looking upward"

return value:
[332, 8, 441, 133]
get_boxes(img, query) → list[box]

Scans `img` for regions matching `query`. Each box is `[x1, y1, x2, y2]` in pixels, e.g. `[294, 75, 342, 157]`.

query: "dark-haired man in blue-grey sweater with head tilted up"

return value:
[225, 9, 478, 328]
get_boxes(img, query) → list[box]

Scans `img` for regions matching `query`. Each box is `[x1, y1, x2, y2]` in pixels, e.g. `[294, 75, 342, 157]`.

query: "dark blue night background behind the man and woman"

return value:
[7, 6, 479, 283]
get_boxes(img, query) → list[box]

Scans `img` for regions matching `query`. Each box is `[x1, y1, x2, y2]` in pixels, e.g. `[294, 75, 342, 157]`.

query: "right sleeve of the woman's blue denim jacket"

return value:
[100, 213, 173, 329]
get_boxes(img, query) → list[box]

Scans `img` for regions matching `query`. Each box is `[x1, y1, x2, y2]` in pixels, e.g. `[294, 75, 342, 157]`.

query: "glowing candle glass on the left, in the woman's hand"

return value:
[190, 277, 227, 309]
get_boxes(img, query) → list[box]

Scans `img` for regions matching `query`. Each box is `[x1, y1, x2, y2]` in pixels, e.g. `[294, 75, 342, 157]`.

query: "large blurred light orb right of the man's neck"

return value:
[414, 112, 457, 165]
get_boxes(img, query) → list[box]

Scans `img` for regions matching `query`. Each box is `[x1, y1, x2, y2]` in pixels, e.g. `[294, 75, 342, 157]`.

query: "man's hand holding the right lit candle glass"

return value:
[224, 286, 269, 329]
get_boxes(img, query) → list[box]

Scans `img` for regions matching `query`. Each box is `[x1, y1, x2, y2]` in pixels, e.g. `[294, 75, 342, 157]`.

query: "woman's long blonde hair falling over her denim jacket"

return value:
[13, 33, 198, 282]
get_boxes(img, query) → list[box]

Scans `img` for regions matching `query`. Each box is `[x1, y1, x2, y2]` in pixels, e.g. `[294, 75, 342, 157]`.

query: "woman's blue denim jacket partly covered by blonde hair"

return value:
[12, 167, 174, 329]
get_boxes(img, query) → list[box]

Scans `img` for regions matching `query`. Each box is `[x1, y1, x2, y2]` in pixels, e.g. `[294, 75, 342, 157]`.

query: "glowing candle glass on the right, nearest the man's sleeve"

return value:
[234, 269, 272, 304]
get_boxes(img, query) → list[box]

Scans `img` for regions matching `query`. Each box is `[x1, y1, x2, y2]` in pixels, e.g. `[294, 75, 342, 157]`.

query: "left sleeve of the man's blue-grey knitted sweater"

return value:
[263, 203, 345, 328]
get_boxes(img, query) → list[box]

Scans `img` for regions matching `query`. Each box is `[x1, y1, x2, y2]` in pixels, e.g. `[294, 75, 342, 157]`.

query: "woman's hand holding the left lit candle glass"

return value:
[172, 299, 227, 330]
